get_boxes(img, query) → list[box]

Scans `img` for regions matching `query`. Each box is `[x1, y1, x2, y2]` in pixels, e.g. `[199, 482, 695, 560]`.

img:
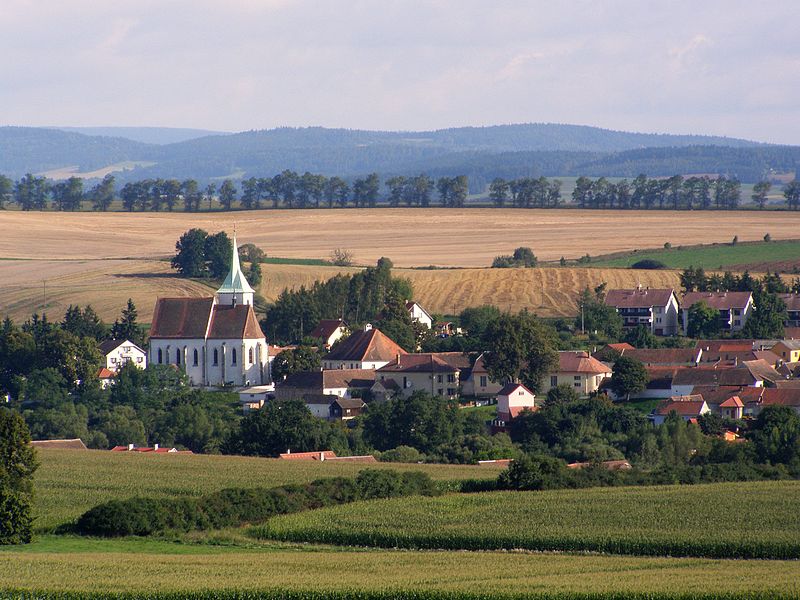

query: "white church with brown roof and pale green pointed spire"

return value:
[148, 234, 269, 387]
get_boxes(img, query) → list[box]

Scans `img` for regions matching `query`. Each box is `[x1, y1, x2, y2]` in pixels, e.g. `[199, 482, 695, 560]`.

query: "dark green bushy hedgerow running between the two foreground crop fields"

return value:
[75, 469, 439, 537]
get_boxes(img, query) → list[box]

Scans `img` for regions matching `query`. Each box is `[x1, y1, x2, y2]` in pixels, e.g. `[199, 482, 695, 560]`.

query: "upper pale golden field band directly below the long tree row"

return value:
[0, 208, 800, 267]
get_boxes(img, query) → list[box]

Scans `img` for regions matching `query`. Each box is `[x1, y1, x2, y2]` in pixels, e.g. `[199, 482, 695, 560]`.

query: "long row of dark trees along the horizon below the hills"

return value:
[0, 170, 800, 212]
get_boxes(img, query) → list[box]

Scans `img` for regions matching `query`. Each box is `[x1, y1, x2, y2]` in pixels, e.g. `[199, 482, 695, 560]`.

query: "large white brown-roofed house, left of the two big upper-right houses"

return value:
[605, 286, 680, 335]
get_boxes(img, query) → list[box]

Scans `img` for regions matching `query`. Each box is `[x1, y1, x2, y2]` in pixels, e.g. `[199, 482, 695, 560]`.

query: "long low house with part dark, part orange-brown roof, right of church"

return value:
[275, 369, 375, 400]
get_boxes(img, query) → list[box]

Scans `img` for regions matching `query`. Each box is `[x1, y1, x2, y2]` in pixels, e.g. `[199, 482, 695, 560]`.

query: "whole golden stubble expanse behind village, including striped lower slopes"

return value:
[0, 209, 800, 323]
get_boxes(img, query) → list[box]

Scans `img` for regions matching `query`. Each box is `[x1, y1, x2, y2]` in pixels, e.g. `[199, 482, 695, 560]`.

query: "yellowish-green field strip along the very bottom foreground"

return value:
[0, 539, 800, 598]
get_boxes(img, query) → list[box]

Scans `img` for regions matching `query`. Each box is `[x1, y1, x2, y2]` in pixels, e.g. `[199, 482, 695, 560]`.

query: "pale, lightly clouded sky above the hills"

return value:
[0, 0, 800, 144]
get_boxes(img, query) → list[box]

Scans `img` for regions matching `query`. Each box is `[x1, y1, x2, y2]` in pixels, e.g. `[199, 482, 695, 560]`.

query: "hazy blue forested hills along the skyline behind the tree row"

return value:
[0, 124, 800, 184]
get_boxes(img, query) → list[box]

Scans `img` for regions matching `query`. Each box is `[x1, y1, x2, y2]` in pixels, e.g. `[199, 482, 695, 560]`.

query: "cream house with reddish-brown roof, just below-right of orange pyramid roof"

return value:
[375, 353, 468, 399]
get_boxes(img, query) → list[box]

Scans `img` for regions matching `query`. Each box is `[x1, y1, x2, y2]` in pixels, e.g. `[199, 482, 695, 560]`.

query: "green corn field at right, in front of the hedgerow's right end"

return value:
[254, 481, 800, 558]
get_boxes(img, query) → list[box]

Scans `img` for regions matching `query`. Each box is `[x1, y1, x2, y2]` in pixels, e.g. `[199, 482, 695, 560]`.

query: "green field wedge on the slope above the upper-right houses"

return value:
[590, 236, 800, 271]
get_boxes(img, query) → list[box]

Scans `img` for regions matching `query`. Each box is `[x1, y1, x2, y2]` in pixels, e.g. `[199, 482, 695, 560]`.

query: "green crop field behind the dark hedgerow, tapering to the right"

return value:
[35, 449, 501, 531]
